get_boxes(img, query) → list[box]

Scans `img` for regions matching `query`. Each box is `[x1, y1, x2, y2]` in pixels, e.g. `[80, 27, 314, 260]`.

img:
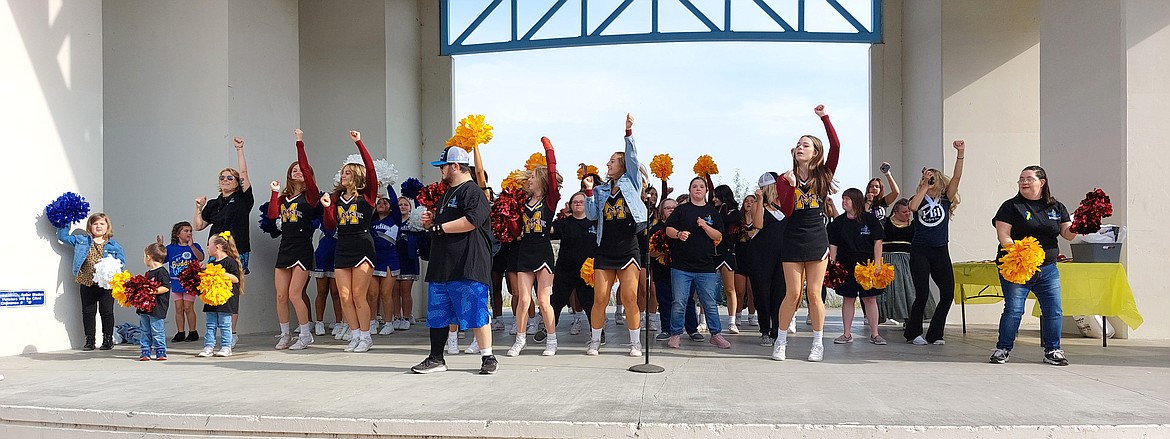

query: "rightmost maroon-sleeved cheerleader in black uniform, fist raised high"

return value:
[776, 105, 841, 362]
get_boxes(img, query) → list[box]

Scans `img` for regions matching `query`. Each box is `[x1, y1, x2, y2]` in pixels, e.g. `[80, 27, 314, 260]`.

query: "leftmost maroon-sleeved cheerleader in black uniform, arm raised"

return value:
[268, 129, 321, 350]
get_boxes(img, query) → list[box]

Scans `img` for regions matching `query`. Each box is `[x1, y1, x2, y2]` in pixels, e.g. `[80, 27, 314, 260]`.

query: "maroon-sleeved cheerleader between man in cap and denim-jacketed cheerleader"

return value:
[508, 137, 562, 357]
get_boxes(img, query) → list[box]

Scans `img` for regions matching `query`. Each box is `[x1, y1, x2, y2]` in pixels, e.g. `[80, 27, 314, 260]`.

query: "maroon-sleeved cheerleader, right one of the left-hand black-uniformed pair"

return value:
[321, 131, 378, 352]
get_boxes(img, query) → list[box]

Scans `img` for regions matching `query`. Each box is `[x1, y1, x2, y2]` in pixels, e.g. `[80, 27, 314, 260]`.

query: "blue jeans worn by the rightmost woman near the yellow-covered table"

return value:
[996, 262, 1064, 351]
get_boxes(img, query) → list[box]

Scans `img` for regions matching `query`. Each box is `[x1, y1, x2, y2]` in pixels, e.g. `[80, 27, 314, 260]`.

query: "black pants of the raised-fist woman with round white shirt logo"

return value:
[902, 246, 955, 343]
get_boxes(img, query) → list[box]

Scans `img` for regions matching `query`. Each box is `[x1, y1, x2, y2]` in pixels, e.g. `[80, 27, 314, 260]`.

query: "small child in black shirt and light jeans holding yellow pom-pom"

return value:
[198, 232, 243, 357]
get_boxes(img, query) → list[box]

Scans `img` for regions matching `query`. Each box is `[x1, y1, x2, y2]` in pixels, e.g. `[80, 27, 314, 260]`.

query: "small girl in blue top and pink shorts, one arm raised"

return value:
[158, 221, 204, 343]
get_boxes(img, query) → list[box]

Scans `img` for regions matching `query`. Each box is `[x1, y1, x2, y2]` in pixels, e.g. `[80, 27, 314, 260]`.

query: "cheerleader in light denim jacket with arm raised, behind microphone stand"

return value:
[585, 114, 646, 357]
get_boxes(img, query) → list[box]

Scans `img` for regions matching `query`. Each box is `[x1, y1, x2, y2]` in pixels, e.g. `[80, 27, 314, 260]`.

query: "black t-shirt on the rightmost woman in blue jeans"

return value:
[991, 196, 1072, 263]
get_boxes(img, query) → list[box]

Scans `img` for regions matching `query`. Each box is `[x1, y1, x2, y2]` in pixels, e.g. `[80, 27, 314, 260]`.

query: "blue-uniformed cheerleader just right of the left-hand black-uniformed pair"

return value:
[367, 185, 402, 335]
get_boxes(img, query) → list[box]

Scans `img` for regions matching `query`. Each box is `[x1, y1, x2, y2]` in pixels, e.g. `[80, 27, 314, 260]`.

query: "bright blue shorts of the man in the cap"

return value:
[427, 280, 491, 329]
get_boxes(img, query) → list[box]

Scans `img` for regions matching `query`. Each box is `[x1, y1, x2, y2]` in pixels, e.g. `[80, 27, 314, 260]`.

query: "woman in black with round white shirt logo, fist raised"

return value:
[902, 140, 966, 345]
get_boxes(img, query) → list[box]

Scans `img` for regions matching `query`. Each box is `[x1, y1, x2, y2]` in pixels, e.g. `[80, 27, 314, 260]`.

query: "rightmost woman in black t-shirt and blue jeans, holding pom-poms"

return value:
[990, 166, 1076, 366]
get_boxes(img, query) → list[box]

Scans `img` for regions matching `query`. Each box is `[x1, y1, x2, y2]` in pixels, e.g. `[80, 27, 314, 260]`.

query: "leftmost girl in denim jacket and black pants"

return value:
[57, 212, 126, 350]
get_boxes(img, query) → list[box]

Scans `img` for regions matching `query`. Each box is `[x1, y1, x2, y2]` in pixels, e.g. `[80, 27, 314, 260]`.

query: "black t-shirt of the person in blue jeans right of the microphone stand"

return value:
[666, 203, 723, 273]
